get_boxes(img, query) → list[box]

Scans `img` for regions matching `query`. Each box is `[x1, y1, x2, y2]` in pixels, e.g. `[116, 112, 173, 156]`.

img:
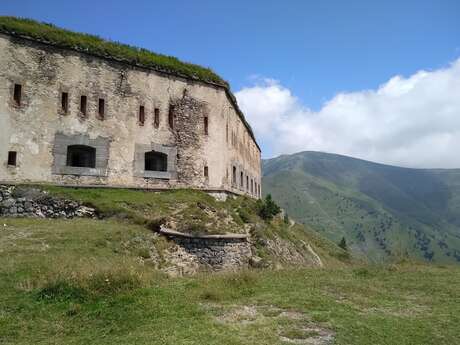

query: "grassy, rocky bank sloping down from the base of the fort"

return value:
[6, 185, 350, 267]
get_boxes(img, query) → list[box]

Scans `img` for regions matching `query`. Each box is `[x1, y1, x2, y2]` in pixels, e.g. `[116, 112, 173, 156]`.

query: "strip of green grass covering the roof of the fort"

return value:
[0, 16, 260, 149]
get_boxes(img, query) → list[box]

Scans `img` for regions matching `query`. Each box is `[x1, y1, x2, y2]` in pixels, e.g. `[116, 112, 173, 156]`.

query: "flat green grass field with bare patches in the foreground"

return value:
[0, 218, 460, 345]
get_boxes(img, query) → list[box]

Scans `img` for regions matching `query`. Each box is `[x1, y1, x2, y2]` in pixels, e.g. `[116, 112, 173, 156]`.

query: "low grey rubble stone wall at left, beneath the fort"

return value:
[0, 185, 95, 218]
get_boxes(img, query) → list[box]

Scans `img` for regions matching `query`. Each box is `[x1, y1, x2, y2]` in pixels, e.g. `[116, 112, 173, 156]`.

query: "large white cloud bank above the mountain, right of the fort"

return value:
[236, 59, 460, 168]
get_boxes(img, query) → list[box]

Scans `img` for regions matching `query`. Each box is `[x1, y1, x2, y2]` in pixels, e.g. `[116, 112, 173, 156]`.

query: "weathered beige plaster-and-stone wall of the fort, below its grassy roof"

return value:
[0, 35, 261, 195]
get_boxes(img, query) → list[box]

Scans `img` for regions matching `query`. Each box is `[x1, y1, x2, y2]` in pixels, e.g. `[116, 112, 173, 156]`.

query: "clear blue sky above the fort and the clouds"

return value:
[0, 0, 460, 165]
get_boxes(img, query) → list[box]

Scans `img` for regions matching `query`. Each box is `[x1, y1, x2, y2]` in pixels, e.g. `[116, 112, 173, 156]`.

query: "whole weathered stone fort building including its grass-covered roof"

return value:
[0, 17, 261, 197]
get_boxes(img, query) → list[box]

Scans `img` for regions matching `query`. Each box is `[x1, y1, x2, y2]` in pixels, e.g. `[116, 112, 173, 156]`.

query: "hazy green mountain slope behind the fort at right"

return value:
[263, 152, 460, 262]
